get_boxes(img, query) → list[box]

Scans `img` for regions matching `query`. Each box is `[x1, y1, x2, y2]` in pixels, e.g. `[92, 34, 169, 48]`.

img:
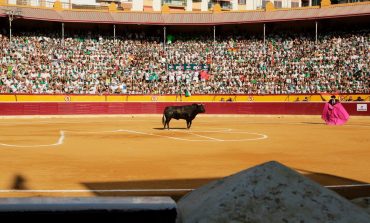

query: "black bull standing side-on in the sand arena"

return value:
[162, 104, 206, 129]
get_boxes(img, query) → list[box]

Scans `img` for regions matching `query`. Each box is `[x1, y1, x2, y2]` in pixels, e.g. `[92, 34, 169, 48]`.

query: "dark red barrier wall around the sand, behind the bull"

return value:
[0, 102, 370, 116]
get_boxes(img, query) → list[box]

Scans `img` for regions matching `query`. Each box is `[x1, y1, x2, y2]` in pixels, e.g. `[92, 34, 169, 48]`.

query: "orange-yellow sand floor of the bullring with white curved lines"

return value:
[0, 115, 370, 197]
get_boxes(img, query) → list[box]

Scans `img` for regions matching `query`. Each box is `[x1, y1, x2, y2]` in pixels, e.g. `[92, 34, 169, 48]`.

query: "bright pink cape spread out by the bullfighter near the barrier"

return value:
[321, 103, 349, 125]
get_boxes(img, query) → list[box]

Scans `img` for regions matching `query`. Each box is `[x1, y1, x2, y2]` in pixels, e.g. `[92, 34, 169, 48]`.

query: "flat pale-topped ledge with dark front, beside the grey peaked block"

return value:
[0, 197, 176, 223]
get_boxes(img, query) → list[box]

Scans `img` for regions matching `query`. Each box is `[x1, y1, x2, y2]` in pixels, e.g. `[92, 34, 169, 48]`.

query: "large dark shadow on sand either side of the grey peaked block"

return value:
[82, 169, 370, 201]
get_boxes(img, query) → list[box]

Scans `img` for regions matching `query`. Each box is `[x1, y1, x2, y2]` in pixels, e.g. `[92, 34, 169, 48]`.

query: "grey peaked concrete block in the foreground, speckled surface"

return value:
[177, 162, 370, 223]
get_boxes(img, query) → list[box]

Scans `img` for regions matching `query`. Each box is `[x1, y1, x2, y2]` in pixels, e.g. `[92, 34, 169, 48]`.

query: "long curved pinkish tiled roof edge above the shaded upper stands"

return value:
[0, 2, 370, 25]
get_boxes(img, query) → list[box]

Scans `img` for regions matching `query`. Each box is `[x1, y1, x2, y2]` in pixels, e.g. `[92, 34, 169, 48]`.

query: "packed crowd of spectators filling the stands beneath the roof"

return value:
[0, 30, 370, 94]
